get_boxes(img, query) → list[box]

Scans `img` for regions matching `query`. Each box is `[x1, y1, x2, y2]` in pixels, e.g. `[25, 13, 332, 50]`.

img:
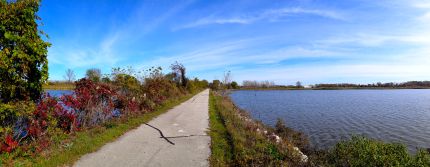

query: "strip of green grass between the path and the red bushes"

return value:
[8, 92, 197, 167]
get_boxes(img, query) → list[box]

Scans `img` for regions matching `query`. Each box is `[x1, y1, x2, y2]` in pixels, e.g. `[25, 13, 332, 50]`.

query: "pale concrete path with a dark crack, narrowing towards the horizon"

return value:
[74, 90, 210, 167]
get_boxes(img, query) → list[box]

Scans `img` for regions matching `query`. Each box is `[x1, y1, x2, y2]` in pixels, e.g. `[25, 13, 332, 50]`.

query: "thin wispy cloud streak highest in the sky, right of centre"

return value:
[176, 7, 346, 29]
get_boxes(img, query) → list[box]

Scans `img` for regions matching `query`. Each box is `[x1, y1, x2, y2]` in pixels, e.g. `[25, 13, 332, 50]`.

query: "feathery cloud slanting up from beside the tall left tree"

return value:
[49, 0, 193, 72]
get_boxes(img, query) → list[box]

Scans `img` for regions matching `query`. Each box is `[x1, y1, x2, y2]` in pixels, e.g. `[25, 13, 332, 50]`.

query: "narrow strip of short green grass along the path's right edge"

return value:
[209, 92, 233, 166]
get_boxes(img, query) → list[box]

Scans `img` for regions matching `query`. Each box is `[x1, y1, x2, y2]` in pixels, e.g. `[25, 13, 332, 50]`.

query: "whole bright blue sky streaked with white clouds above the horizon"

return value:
[39, 0, 430, 84]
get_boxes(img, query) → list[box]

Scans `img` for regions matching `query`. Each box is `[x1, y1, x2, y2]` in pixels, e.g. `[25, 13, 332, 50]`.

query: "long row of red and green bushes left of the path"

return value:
[0, 64, 200, 162]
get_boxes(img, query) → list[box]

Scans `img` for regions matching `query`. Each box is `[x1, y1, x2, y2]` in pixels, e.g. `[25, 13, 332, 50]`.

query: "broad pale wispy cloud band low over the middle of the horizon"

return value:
[138, 38, 343, 72]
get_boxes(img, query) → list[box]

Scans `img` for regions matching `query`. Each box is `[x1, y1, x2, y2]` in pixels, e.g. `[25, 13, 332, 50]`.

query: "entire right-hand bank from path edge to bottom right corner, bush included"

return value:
[209, 92, 430, 167]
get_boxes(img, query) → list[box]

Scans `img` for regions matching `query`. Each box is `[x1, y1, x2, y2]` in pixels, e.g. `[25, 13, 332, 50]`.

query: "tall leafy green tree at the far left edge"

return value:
[0, 0, 51, 102]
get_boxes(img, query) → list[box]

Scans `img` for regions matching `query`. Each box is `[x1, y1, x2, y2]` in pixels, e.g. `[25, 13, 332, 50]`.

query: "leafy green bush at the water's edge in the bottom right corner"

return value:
[326, 136, 430, 166]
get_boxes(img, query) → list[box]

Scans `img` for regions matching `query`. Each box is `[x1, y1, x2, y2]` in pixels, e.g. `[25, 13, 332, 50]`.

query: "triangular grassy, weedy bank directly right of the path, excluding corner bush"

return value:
[209, 92, 304, 166]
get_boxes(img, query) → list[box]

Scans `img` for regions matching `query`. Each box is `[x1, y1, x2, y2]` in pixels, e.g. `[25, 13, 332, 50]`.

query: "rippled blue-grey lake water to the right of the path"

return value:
[231, 89, 430, 152]
